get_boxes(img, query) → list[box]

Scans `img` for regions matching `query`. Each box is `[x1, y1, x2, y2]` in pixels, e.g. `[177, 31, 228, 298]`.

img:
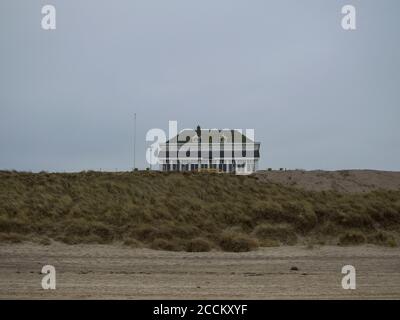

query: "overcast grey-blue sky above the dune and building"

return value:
[0, 0, 400, 172]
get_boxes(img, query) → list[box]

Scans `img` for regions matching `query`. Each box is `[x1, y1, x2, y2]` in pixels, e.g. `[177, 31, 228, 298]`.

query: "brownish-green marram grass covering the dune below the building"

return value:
[0, 171, 400, 252]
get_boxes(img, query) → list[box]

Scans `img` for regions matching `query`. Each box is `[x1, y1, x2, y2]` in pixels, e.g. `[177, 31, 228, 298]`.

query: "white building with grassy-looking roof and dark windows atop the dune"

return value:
[158, 126, 260, 174]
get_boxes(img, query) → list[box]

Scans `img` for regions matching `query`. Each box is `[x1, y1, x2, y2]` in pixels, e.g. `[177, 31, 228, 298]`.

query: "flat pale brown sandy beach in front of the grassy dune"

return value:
[0, 243, 400, 299]
